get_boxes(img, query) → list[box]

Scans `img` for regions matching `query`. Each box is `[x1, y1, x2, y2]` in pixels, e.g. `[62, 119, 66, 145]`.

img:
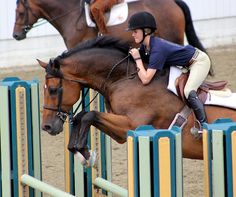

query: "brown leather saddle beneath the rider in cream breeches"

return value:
[175, 73, 228, 103]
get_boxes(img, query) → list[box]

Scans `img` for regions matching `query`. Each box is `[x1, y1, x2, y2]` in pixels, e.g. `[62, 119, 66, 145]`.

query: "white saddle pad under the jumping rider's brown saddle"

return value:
[167, 66, 236, 109]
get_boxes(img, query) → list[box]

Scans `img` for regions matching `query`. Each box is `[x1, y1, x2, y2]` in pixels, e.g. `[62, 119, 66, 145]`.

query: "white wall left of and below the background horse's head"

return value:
[0, 0, 66, 68]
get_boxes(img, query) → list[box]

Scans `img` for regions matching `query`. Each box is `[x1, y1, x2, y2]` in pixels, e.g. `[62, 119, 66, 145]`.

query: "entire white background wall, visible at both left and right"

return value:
[0, 0, 236, 68]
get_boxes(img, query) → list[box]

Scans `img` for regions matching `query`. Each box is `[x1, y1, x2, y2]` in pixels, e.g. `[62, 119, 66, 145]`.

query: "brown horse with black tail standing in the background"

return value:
[13, 0, 205, 51]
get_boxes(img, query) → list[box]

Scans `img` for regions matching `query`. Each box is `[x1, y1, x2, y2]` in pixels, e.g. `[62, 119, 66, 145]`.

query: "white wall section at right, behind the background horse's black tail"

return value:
[185, 0, 236, 47]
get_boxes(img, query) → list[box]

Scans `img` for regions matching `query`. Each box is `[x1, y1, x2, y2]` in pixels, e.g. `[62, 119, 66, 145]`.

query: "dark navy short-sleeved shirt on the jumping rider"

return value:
[140, 36, 196, 70]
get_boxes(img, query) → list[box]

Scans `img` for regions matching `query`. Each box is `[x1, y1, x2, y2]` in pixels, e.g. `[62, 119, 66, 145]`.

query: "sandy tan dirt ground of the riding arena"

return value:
[0, 45, 236, 197]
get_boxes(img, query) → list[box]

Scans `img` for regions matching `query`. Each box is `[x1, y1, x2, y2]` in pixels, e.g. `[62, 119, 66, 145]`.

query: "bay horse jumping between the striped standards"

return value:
[38, 37, 236, 162]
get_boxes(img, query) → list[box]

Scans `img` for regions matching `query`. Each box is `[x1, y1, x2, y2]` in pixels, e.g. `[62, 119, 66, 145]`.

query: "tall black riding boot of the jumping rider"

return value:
[188, 90, 207, 125]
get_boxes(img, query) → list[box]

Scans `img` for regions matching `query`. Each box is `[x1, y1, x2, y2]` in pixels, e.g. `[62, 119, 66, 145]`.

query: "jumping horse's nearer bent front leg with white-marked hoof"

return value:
[76, 111, 147, 166]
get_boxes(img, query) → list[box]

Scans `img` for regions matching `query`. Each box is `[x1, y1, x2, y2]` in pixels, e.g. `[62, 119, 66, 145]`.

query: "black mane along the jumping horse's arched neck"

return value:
[58, 36, 130, 59]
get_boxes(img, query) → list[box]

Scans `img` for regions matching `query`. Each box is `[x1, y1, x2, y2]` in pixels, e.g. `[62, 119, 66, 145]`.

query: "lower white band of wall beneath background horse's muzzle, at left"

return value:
[0, 35, 66, 68]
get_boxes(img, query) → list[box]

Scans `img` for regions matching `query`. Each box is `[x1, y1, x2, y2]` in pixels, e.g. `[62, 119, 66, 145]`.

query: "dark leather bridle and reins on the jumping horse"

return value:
[43, 54, 137, 122]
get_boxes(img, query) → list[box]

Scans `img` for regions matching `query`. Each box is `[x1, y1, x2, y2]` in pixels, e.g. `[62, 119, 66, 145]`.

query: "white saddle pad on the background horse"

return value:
[85, 0, 139, 27]
